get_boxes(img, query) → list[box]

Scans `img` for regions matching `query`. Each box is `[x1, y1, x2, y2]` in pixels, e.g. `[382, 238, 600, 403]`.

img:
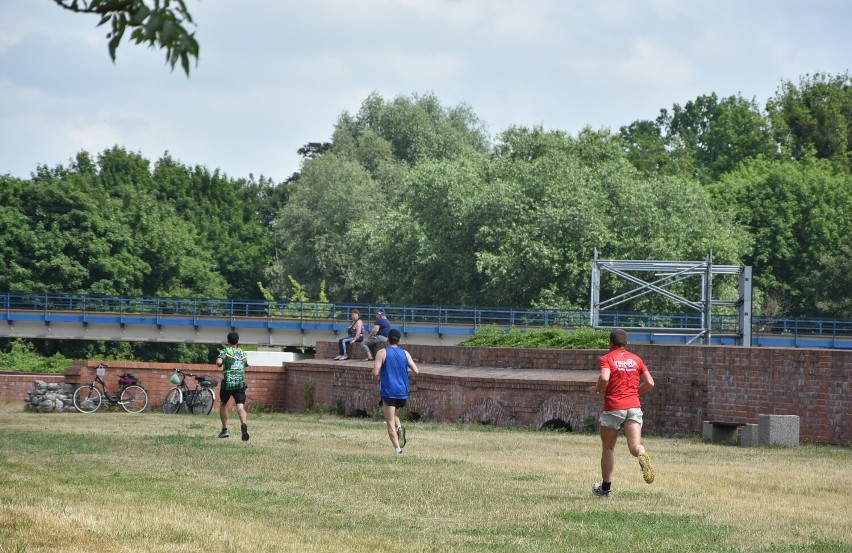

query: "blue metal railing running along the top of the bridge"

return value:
[0, 292, 852, 348]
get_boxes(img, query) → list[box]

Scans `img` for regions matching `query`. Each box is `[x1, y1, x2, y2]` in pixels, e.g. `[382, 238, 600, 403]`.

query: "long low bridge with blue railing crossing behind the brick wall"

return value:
[0, 292, 852, 349]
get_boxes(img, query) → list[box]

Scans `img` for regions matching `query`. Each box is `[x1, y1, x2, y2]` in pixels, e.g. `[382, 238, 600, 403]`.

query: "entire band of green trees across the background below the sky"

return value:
[0, 76, 852, 362]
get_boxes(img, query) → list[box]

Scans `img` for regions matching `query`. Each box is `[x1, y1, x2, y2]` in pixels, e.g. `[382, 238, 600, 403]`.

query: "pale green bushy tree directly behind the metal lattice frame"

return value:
[477, 128, 747, 308]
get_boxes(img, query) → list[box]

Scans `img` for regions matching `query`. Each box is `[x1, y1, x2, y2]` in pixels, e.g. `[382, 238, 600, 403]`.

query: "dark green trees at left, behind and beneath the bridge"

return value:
[0, 148, 286, 362]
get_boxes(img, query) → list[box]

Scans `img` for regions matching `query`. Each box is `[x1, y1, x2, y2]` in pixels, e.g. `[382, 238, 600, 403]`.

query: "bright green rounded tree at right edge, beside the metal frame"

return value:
[710, 158, 852, 316]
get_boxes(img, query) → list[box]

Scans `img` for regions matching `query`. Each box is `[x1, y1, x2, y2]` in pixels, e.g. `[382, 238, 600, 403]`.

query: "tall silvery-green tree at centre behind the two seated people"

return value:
[269, 93, 487, 301]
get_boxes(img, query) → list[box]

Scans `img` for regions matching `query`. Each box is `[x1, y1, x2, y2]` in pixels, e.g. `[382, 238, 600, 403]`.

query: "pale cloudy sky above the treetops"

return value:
[0, 0, 852, 183]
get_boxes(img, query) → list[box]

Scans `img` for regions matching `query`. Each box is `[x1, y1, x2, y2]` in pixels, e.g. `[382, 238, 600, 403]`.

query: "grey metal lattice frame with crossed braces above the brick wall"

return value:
[590, 249, 752, 346]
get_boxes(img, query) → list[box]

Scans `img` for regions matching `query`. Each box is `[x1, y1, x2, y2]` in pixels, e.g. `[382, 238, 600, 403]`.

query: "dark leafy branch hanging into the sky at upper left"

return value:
[53, 0, 199, 76]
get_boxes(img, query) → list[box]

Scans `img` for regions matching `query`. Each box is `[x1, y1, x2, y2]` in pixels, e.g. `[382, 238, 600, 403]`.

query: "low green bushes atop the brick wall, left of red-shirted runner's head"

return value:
[459, 326, 609, 349]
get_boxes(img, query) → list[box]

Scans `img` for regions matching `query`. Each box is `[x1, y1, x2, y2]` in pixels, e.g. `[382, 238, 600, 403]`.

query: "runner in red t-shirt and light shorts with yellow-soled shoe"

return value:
[589, 329, 655, 497]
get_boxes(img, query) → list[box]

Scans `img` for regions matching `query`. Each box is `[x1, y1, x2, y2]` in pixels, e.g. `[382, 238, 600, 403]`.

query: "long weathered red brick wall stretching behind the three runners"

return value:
[0, 342, 852, 444]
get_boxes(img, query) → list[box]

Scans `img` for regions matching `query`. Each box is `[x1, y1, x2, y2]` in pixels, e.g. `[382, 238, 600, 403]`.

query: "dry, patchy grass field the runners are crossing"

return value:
[0, 404, 852, 553]
